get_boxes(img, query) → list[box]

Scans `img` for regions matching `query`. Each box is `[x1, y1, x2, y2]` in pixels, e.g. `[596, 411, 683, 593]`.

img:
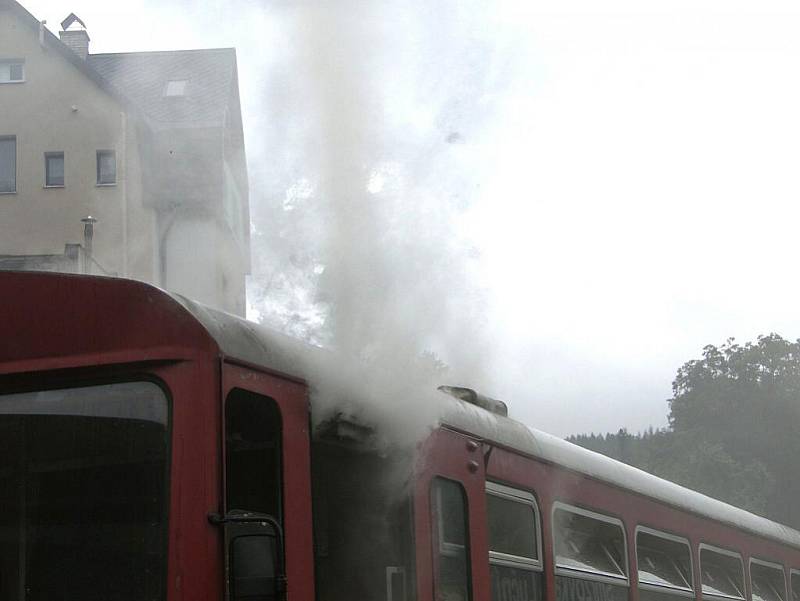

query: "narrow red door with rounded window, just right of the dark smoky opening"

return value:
[414, 429, 490, 601]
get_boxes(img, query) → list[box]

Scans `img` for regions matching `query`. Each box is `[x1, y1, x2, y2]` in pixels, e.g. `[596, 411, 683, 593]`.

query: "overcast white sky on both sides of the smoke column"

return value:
[23, 0, 800, 435]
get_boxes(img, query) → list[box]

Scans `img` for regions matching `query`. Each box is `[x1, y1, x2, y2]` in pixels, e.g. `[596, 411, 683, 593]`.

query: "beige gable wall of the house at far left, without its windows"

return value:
[0, 10, 147, 275]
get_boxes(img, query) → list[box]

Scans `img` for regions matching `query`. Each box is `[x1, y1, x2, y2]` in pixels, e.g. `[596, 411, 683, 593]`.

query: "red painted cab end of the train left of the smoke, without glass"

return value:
[0, 272, 314, 601]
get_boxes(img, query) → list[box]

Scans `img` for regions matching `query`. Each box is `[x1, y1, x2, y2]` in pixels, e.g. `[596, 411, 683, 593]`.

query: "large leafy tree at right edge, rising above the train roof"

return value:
[669, 334, 800, 524]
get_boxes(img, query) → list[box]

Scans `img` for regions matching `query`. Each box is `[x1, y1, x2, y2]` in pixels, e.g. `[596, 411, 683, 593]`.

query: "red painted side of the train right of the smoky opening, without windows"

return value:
[414, 429, 800, 601]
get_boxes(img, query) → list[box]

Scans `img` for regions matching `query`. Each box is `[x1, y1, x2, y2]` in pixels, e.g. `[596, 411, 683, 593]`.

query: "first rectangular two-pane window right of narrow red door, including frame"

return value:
[486, 482, 544, 601]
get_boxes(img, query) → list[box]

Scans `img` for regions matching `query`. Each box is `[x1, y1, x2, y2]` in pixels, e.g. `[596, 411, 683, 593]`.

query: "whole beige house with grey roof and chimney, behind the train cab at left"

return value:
[0, 0, 250, 315]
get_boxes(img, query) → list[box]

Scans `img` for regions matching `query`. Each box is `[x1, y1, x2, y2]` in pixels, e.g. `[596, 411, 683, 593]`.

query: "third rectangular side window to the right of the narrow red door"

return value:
[636, 526, 694, 598]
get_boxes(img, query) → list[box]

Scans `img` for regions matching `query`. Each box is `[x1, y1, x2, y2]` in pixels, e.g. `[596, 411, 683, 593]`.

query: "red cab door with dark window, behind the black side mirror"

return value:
[222, 363, 314, 601]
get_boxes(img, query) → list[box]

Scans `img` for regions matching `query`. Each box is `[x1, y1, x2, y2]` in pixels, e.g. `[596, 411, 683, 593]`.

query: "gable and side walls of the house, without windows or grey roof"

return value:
[0, 3, 249, 315]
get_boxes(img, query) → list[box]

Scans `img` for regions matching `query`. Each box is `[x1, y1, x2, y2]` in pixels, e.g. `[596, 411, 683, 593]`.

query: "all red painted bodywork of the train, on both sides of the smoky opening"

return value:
[6, 272, 800, 601]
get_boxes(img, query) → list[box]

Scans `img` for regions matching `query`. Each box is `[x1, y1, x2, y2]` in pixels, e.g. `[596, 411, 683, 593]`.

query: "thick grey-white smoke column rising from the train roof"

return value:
[248, 1, 512, 443]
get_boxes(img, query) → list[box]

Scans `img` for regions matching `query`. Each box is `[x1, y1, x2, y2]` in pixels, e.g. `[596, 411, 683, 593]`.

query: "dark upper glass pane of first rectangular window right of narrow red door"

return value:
[486, 492, 539, 560]
